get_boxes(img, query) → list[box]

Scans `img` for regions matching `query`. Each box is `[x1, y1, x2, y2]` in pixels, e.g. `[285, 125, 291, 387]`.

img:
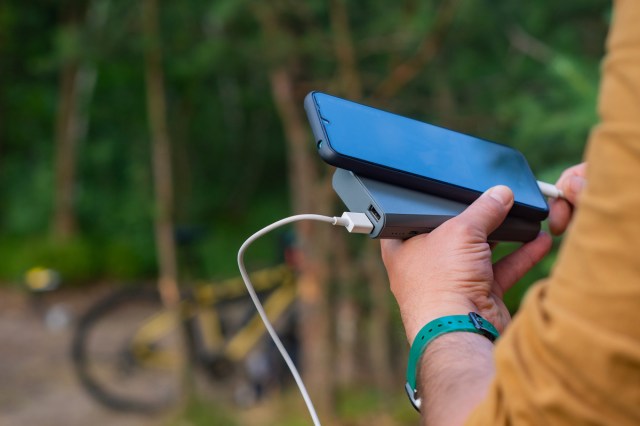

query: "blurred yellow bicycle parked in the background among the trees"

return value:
[72, 264, 295, 413]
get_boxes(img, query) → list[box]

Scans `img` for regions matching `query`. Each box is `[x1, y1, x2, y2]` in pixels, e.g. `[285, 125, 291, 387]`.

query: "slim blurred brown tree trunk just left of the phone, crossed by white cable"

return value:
[271, 68, 334, 421]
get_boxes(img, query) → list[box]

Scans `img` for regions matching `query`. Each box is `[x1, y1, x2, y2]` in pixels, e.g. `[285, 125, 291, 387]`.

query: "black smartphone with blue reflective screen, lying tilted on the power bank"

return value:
[304, 92, 549, 221]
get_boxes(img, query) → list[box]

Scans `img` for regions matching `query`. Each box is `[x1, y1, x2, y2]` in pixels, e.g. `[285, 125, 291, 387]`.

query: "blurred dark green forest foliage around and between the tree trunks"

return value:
[0, 0, 611, 306]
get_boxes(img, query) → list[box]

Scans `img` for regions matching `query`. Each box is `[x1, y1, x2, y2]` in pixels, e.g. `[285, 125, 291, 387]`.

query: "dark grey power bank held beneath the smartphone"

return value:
[333, 169, 540, 242]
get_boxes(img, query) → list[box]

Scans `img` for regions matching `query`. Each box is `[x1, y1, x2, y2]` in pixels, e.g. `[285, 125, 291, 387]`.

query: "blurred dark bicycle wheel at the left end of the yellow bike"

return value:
[72, 289, 188, 413]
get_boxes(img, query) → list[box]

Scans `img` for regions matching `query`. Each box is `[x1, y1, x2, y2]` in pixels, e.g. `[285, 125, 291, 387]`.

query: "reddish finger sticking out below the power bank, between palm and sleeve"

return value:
[493, 233, 552, 294]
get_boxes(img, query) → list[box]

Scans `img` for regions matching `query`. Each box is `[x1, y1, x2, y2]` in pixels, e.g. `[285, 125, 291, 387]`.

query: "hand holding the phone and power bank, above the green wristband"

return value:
[381, 186, 551, 343]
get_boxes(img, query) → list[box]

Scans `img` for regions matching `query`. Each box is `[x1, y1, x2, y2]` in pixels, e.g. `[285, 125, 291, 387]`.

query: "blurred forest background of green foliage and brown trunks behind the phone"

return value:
[0, 0, 611, 424]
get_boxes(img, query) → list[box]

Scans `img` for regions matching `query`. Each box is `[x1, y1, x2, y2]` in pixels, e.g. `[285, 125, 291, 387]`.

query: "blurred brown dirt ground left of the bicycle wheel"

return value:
[0, 286, 165, 426]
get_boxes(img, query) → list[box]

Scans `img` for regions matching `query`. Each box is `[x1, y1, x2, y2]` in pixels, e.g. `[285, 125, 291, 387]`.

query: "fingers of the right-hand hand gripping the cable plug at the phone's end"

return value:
[549, 163, 587, 235]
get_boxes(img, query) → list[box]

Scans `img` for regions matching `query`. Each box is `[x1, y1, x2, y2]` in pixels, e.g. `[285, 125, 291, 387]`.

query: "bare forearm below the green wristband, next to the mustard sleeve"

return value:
[418, 332, 495, 426]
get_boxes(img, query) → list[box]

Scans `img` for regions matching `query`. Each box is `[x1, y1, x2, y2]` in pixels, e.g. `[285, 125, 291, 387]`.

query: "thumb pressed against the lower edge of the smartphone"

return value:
[454, 185, 513, 239]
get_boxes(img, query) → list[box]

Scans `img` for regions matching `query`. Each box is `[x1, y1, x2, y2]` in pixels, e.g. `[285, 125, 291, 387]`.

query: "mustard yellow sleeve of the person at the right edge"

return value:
[467, 0, 640, 425]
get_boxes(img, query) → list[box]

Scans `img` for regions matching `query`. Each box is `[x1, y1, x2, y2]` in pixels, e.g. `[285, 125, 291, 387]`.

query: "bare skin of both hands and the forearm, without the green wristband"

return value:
[381, 163, 586, 425]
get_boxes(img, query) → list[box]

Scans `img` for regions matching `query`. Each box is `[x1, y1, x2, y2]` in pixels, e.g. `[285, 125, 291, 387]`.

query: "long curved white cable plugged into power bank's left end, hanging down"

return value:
[238, 212, 373, 426]
